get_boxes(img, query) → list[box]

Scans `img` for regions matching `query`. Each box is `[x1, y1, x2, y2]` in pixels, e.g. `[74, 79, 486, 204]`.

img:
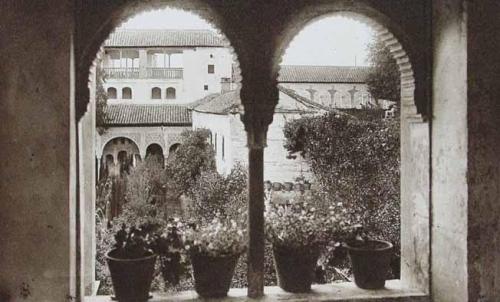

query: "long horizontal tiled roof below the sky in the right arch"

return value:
[278, 65, 371, 83]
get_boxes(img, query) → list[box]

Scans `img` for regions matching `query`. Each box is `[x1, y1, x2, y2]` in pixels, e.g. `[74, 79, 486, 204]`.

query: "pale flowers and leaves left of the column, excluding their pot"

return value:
[184, 217, 247, 257]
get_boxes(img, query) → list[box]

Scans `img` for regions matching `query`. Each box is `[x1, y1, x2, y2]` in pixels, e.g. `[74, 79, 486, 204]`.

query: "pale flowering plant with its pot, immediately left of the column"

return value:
[184, 217, 246, 298]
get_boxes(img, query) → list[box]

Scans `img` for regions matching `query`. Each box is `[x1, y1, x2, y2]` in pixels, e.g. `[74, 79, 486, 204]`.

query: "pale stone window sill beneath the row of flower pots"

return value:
[84, 280, 430, 302]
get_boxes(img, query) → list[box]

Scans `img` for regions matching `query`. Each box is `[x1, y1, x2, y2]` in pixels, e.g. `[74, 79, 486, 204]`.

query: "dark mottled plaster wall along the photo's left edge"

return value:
[0, 0, 76, 302]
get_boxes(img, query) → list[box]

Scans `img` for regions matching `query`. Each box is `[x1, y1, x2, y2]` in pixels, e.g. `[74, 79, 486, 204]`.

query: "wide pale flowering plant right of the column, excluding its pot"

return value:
[266, 192, 358, 249]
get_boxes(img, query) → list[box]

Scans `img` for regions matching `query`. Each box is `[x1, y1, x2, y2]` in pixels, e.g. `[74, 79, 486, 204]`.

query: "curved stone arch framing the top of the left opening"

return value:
[75, 0, 241, 120]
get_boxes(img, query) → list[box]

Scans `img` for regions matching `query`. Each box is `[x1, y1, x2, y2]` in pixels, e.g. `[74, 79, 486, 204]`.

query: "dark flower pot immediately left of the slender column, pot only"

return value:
[191, 253, 240, 298]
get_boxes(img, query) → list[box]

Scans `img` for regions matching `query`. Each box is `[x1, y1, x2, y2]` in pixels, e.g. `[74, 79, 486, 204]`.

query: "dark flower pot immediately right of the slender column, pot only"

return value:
[273, 246, 319, 293]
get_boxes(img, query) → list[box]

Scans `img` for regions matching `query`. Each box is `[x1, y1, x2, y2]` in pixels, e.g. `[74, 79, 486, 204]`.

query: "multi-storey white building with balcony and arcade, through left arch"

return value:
[96, 30, 233, 174]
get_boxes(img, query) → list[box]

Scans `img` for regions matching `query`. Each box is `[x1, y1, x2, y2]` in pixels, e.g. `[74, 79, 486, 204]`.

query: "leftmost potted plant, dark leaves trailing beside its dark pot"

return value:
[106, 219, 182, 302]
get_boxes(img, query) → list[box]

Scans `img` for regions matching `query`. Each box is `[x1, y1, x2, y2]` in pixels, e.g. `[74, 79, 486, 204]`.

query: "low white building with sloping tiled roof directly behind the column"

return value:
[192, 86, 328, 182]
